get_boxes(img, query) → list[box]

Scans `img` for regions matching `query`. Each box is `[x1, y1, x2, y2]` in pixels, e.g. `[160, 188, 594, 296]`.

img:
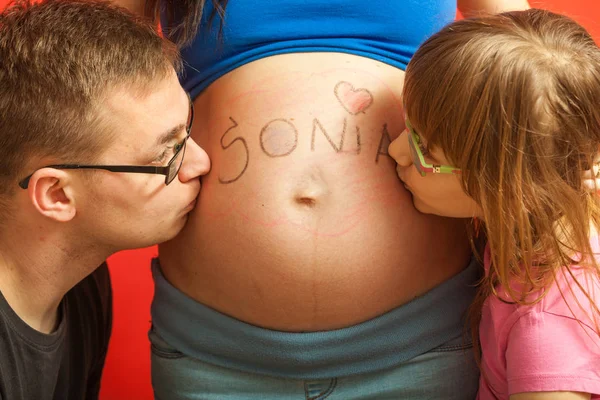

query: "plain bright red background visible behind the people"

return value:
[0, 0, 600, 400]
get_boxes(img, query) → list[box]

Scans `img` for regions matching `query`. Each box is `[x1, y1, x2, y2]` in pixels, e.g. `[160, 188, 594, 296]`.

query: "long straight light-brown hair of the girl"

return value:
[404, 9, 600, 360]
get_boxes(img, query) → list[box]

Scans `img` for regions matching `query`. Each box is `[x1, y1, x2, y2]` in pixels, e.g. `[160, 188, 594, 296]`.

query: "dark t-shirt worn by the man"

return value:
[0, 263, 112, 400]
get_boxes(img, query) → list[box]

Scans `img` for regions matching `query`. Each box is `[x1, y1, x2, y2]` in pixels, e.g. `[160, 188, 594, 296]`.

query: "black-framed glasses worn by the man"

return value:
[19, 95, 194, 189]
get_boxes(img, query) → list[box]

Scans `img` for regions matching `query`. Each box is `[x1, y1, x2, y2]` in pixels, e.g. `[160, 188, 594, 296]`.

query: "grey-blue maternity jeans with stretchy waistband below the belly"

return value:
[149, 260, 480, 400]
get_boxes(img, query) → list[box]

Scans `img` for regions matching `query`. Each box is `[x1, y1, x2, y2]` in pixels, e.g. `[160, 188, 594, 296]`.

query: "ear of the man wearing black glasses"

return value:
[27, 168, 77, 222]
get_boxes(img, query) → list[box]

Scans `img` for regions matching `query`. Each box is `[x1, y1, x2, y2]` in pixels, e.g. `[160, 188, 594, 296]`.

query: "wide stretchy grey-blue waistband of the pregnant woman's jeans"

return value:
[151, 259, 481, 379]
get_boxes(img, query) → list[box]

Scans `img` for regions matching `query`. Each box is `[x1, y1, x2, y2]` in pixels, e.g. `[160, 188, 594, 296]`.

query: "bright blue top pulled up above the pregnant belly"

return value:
[171, 0, 456, 97]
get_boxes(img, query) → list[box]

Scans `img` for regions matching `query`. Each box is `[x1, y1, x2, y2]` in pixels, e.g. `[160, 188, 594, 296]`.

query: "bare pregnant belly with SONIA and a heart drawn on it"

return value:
[159, 53, 469, 331]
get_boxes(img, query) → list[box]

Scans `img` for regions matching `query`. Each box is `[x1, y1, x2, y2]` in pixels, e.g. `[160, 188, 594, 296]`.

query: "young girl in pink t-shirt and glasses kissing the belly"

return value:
[389, 10, 600, 400]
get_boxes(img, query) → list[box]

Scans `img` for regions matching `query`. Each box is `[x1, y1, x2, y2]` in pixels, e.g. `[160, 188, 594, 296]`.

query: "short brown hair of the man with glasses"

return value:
[0, 0, 179, 208]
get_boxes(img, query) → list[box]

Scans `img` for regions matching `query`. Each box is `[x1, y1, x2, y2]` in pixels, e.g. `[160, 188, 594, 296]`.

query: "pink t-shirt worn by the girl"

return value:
[477, 246, 600, 400]
